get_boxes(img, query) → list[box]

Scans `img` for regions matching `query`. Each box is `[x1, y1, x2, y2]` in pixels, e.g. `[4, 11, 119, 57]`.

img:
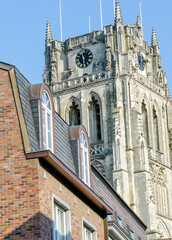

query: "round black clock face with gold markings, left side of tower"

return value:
[75, 49, 93, 68]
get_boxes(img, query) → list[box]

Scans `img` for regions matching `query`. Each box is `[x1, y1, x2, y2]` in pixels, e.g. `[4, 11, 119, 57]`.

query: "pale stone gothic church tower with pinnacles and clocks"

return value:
[43, 0, 172, 239]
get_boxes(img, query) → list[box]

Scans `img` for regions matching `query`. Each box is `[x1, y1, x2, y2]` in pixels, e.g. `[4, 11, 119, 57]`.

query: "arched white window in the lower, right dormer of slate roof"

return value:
[80, 132, 90, 186]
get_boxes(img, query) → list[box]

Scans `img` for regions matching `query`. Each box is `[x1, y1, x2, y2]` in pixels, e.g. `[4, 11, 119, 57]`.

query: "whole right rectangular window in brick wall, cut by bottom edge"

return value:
[82, 218, 97, 240]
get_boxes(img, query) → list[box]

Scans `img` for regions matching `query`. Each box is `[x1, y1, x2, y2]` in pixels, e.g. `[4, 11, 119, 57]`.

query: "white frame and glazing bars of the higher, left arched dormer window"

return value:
[42, 90, 54, 152]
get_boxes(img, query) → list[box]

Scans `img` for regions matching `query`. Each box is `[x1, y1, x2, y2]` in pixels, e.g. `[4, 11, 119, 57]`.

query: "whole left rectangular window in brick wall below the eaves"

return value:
[53, 194, 71, 240]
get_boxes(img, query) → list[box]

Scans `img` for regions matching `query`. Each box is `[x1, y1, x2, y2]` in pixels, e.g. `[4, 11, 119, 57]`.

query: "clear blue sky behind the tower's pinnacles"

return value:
[0, 0, 172, 94]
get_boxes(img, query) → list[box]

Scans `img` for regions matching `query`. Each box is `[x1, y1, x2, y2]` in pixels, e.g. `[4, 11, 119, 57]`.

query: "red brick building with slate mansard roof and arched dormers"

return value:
[0, 63, 146, 240]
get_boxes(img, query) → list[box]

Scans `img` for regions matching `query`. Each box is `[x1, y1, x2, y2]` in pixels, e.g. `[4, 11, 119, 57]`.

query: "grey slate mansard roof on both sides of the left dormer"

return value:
[0, 62, 76, 174]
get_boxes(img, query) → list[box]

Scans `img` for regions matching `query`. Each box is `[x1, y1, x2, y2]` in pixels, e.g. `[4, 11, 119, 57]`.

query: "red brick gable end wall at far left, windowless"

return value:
[0, 70, 40, 239]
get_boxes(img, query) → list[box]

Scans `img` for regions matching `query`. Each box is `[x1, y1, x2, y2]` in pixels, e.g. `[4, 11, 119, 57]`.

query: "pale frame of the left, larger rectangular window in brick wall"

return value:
[52, 193, 72, 240]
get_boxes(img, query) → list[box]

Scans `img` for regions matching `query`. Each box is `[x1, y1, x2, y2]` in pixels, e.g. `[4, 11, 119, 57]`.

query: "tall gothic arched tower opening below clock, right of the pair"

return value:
[88, 95, 102, 144]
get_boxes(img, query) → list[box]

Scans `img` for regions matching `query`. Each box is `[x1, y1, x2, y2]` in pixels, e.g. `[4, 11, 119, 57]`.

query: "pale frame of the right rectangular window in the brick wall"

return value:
[82, 217, 97, 240]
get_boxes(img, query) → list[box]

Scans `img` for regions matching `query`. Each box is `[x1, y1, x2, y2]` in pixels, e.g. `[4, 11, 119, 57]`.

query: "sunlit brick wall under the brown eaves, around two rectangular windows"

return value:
[39, 162, 105, 240]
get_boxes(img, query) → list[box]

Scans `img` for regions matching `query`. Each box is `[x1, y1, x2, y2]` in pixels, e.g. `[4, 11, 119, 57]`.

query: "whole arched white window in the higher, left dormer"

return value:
[42, 91, 53, 151]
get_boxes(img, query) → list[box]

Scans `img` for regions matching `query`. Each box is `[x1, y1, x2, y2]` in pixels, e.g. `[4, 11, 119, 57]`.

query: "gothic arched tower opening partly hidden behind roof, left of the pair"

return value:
[69, 99, 81, 126]
